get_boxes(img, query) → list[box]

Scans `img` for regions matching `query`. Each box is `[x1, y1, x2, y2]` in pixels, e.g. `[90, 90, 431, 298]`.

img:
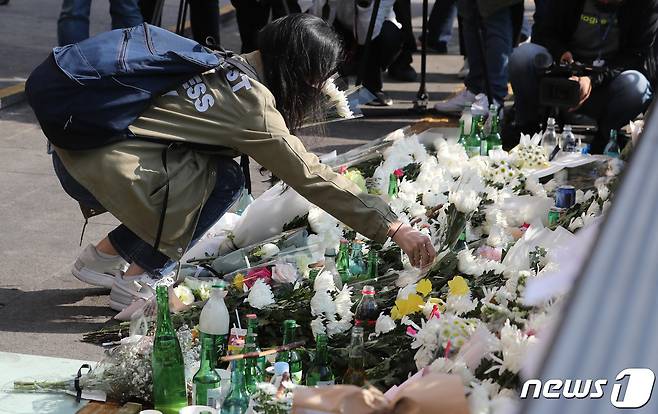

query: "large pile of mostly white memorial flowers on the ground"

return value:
[72, 130, 615, 413]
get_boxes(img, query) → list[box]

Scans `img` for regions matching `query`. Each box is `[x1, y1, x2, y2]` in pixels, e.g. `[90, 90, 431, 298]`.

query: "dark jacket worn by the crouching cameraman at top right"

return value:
[532, 0, 658, 85]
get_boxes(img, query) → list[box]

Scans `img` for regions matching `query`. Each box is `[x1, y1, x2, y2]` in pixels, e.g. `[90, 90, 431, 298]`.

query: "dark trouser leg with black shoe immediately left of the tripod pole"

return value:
[388, 0, 418, 82]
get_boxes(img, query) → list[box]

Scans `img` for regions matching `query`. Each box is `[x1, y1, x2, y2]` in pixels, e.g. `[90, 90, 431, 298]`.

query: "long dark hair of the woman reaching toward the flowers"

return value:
[258, 14, 342, 131]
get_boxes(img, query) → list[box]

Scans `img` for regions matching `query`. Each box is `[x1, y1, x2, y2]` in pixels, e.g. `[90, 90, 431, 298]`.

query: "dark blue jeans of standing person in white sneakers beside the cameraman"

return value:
[458, 0, 514, 105]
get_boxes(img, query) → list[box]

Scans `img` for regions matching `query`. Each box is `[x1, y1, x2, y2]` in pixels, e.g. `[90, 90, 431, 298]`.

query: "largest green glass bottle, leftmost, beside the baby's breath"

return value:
[152, 286, 187, 414]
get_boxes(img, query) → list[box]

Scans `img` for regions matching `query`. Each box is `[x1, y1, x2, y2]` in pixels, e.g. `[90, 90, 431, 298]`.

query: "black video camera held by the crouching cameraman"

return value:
[534, 54, 602, 109]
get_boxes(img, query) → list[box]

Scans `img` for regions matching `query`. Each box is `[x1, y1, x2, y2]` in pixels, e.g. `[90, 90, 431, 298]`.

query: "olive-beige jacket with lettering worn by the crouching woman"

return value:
[56, 52, 396, 259]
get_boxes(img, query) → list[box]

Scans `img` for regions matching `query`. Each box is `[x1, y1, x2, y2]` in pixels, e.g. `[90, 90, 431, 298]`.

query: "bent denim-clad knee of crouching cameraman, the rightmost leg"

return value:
[578, 70, 653, 153]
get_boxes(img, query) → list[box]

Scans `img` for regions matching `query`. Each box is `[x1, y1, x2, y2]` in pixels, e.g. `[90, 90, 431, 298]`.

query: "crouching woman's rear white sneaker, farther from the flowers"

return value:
[71, 244, 128, 288]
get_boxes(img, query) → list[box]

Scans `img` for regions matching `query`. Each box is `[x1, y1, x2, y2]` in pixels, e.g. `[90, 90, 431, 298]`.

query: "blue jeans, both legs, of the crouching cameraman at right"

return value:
[509, 43, 653, 137]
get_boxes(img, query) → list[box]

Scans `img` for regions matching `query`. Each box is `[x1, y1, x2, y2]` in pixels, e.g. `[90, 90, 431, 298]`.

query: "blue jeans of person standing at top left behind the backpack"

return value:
[57, 0, 143, 46]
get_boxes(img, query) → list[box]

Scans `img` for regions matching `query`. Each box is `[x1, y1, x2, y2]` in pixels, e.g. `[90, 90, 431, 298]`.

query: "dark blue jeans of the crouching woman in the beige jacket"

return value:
[53, 153, 244, 275]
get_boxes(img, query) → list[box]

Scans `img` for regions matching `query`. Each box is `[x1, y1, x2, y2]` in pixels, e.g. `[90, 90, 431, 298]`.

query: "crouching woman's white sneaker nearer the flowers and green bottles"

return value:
[110, 273, 176, 312]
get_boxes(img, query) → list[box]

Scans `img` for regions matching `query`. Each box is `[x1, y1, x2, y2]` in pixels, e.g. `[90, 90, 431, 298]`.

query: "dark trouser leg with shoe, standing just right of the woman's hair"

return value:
[359, 20, 403, 106]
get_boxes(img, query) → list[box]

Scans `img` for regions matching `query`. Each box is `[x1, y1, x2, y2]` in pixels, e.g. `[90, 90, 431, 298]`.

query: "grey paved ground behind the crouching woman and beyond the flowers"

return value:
[0, 0, 462, 360]
